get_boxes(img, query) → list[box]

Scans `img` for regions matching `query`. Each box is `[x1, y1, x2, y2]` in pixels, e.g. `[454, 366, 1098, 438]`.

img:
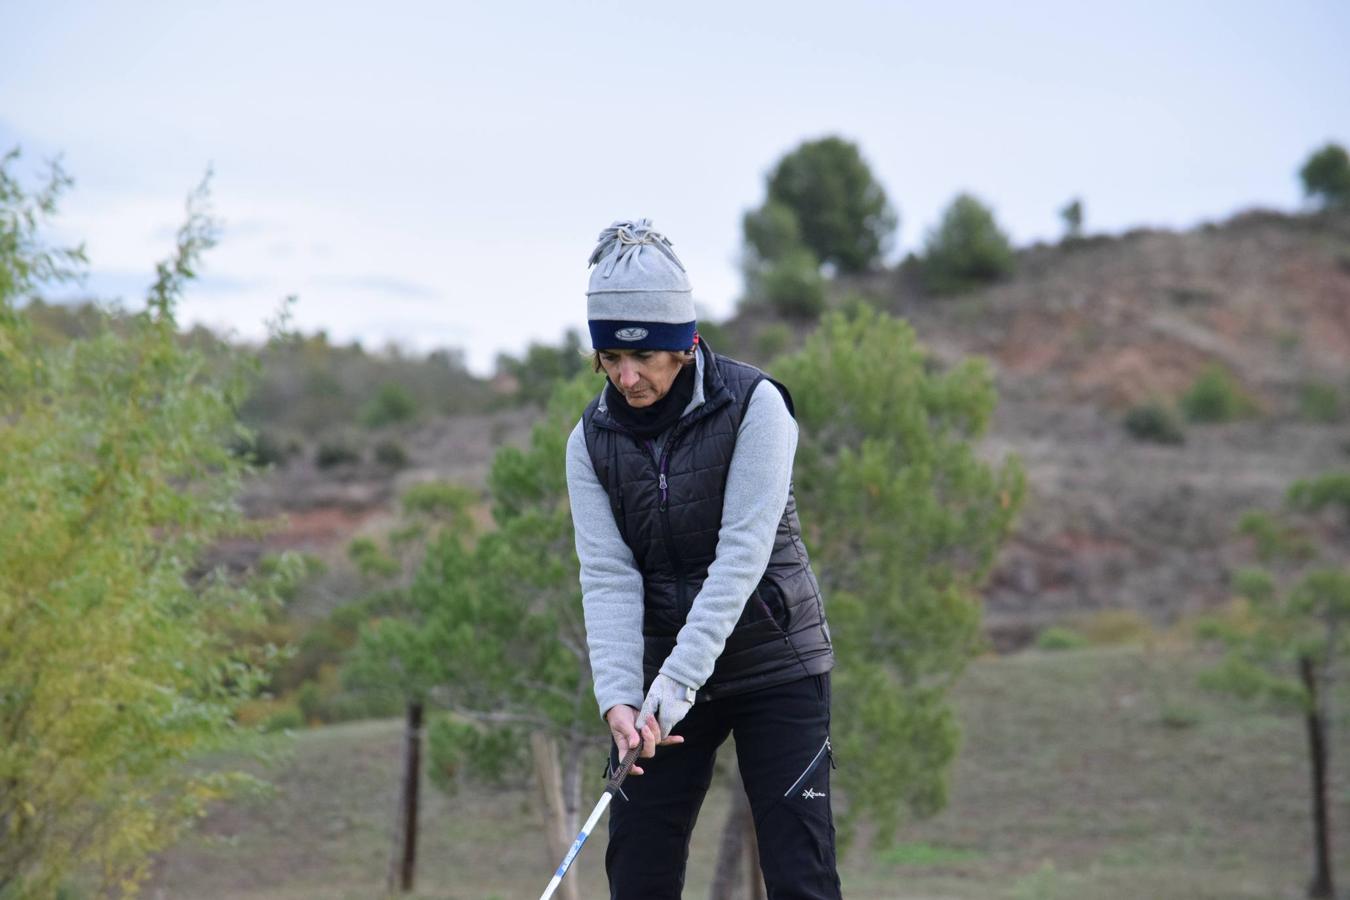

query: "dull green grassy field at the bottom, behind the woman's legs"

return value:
[146, 648, 1350, 900]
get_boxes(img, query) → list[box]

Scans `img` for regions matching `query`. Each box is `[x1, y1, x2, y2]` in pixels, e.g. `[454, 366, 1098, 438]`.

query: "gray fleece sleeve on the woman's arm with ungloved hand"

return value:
[567, 422, 643, 715]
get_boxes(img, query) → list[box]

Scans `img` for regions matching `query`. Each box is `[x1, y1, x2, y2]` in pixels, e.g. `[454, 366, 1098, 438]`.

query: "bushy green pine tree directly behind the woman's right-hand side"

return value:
[772, 304, 1025, 842]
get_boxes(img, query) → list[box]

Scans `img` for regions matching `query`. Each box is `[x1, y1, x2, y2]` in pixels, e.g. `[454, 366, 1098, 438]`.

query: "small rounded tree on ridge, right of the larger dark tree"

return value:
[923, 194, 1014, 294]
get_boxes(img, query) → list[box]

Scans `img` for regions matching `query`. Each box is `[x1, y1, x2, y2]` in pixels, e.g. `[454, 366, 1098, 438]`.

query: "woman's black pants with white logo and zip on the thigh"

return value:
[605, 675, 840, 900]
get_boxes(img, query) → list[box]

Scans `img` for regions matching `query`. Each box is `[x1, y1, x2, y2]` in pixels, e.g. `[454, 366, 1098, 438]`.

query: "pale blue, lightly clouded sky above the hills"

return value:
[0, 0, 1350, 374]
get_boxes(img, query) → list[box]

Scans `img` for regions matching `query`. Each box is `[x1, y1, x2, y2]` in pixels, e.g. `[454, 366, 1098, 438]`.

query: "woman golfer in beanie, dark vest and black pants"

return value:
[567, 219, 840, 900]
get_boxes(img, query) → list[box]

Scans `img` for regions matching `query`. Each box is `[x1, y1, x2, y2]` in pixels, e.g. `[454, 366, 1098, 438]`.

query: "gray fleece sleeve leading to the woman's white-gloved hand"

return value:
[662, 381, 797, 688]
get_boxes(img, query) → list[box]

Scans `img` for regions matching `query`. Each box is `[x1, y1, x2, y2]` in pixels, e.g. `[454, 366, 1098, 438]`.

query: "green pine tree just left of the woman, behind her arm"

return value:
[352, 372, 605, 896]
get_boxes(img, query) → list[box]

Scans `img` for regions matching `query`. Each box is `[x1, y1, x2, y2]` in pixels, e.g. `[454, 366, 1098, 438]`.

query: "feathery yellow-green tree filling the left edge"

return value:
[0, 152, 284, 897]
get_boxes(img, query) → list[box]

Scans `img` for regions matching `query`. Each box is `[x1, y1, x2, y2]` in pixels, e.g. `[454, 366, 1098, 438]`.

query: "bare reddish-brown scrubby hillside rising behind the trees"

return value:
[237, 212, 1350, 646]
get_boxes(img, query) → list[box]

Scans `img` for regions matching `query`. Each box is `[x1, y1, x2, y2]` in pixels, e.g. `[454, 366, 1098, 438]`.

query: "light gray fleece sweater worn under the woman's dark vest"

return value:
[567, 354, 797, 715]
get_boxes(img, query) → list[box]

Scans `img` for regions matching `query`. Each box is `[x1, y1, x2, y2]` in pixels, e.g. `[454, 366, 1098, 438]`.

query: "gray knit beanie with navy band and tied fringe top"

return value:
[586, 219, 695, 349]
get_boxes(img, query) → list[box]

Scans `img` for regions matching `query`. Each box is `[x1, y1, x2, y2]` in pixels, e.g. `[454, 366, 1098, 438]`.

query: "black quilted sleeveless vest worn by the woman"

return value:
[582, 343, 834, 702]
